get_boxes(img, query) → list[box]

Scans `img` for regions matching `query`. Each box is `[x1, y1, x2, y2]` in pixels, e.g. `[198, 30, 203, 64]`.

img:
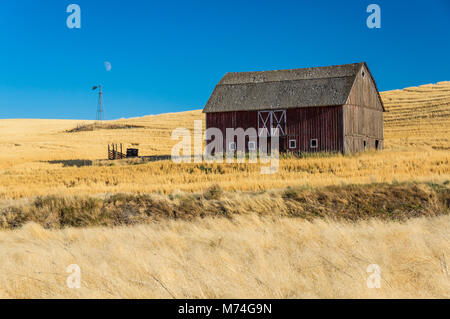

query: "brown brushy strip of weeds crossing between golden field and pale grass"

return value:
[0, 183, 450, 229]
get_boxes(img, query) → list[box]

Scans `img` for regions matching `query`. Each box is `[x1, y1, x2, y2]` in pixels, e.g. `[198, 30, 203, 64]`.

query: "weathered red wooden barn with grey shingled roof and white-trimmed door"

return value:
[203, 62, 384, 154]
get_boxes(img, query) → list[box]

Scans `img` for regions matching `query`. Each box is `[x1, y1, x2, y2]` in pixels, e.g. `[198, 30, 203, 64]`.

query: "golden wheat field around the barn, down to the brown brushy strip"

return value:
[0, 82, 450, 199]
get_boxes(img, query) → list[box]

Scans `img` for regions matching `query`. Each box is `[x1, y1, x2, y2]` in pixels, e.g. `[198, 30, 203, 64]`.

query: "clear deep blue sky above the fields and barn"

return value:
[0, 0, 450, 119]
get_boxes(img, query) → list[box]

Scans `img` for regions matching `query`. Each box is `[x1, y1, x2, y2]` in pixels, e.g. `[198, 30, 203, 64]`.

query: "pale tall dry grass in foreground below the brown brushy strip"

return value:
[0, 215, 450, 298]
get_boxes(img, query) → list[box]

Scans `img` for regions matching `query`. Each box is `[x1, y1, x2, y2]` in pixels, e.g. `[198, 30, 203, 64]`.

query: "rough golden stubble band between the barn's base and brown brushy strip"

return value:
[0, 150, 450, 199]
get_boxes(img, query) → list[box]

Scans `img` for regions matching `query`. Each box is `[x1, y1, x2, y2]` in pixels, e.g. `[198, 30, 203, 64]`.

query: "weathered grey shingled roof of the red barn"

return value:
[203, 62, 381, 113]
